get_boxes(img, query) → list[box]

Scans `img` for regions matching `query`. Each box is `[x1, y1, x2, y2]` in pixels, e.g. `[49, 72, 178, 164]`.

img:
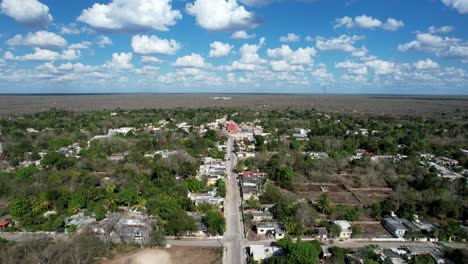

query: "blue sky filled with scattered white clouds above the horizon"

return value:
[0, 0, 468, 95]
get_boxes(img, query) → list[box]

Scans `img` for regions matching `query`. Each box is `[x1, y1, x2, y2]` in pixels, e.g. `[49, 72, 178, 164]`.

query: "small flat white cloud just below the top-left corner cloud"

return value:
[6, 31, 68, 50]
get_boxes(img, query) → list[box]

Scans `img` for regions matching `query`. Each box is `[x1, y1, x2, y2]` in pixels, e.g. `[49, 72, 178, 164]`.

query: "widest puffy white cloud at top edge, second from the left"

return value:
[77, 0, 182, 32]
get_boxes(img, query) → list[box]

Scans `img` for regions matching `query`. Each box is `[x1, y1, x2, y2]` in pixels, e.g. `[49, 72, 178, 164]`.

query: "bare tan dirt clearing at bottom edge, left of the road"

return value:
[102, 247, 222, 264]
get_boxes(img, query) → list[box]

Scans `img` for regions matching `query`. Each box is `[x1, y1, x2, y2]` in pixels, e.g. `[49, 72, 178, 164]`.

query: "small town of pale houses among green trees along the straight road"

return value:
[0, 108, 468, 263]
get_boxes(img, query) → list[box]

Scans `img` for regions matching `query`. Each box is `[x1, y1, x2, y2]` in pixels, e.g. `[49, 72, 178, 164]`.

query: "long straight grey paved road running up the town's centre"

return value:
[223, 138, 245, 264]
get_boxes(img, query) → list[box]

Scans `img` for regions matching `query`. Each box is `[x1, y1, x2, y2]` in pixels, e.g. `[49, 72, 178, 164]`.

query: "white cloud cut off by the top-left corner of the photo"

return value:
[0, 0, 54, 28]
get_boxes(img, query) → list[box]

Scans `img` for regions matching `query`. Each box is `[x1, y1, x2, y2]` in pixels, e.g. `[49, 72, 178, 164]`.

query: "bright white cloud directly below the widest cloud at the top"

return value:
[132, 35, 181, 55]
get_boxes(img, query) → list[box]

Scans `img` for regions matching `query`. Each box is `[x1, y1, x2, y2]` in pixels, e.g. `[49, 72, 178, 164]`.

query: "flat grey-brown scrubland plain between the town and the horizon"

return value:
[0, 94, 468, 115]
